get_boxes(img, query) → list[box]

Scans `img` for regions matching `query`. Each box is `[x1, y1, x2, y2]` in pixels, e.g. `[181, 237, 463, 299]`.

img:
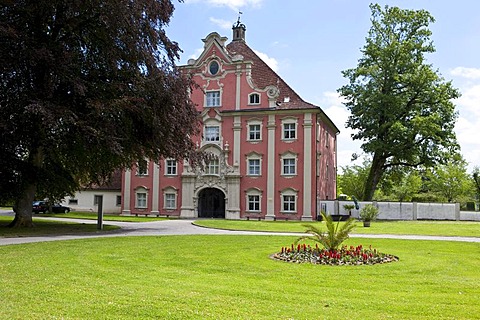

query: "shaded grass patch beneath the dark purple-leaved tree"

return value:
[0, 216, 119, 238]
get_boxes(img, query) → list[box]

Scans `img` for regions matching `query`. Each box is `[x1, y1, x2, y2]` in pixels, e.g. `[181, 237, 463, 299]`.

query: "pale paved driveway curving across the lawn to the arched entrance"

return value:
[0, 218, 480, 245]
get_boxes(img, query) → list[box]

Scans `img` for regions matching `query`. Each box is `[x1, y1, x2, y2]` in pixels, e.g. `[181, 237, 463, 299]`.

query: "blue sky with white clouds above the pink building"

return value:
[166, 0, 480, 172]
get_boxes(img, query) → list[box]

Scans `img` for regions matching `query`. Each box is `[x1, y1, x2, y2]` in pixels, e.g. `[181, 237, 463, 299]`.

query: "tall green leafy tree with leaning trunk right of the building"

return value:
[338, 4, 459, 200]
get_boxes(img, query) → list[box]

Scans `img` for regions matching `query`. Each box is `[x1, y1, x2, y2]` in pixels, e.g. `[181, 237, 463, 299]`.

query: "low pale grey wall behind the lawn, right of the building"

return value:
[319, 200, 480, 221]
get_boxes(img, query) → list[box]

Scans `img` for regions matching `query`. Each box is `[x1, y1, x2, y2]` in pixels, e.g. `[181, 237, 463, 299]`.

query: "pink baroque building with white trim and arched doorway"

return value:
[122, 22, 339, 220]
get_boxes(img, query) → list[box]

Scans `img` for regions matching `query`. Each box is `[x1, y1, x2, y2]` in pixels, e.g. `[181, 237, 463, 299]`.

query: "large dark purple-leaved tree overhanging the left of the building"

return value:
[0, 0, 197, 226]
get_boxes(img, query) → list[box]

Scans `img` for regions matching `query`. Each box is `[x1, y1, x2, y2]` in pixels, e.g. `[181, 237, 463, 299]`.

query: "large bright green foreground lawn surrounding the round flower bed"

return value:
[0, 235, 480, 320]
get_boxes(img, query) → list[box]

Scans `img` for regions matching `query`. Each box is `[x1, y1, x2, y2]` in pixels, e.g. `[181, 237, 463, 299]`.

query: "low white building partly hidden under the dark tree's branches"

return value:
[62, 190, 121, 213]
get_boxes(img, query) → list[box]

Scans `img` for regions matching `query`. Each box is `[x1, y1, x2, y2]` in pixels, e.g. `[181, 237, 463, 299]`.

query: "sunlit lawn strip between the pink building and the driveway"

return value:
[195, 219, 480, 237]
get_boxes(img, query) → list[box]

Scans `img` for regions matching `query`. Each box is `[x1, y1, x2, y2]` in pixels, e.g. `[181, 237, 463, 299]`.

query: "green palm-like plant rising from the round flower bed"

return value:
[296, 212, 355, 251]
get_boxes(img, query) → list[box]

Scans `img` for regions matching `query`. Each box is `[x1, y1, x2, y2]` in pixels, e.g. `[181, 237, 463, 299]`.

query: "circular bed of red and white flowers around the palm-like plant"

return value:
[272, 244, 399, 265]
